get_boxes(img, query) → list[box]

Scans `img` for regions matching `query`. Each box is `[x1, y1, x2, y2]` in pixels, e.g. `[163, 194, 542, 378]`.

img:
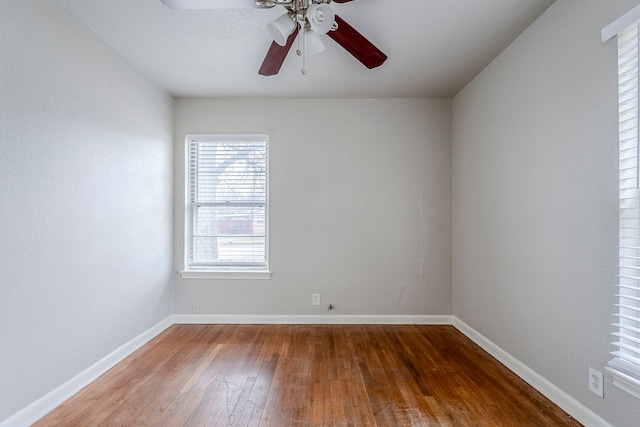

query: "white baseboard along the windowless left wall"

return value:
[0, 316, 173, 427]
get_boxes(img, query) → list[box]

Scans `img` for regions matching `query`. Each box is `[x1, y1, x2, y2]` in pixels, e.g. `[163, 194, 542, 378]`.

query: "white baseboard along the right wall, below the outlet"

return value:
[453, 316, 613, 427]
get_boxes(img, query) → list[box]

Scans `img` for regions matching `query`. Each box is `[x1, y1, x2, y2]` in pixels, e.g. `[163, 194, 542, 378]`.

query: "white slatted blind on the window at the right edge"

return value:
[608, 22, 640, 397]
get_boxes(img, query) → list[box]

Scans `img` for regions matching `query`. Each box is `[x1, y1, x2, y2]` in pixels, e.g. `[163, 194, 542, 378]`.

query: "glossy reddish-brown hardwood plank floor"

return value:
[35, 325, 580, 427]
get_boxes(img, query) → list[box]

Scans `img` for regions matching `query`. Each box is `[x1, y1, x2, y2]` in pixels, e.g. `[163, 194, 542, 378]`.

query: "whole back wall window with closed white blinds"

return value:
[182, 135, 269, 278]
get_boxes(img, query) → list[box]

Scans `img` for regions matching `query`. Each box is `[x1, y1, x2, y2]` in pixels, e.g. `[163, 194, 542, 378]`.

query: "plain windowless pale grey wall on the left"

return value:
[0, 0, 173, 422]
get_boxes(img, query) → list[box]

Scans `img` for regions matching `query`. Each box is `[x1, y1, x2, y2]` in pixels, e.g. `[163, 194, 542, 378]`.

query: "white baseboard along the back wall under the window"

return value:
[173, 314, 453, 325]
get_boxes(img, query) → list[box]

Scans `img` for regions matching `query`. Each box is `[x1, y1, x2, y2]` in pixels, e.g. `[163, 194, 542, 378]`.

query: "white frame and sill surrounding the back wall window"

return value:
[179, 134, 271, 279]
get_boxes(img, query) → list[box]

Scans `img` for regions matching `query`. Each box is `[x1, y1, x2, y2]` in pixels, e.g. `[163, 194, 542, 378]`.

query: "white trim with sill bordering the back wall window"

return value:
[178, 134, 271, 280]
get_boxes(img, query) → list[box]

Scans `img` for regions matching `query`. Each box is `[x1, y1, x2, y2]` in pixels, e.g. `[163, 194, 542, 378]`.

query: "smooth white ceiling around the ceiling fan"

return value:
[59, 0, 554, 98]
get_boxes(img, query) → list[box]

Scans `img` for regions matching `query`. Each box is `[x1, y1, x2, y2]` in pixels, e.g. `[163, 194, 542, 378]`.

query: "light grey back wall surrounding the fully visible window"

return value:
[175, 99, 451, 315]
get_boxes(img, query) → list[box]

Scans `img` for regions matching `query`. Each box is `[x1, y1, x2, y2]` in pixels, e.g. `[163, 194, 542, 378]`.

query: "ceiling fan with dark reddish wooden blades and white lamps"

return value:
[161, 0, 387, 76]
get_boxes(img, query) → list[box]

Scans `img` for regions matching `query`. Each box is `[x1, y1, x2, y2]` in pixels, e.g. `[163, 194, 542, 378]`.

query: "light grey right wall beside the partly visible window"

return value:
[453, 0, 640, 427]
